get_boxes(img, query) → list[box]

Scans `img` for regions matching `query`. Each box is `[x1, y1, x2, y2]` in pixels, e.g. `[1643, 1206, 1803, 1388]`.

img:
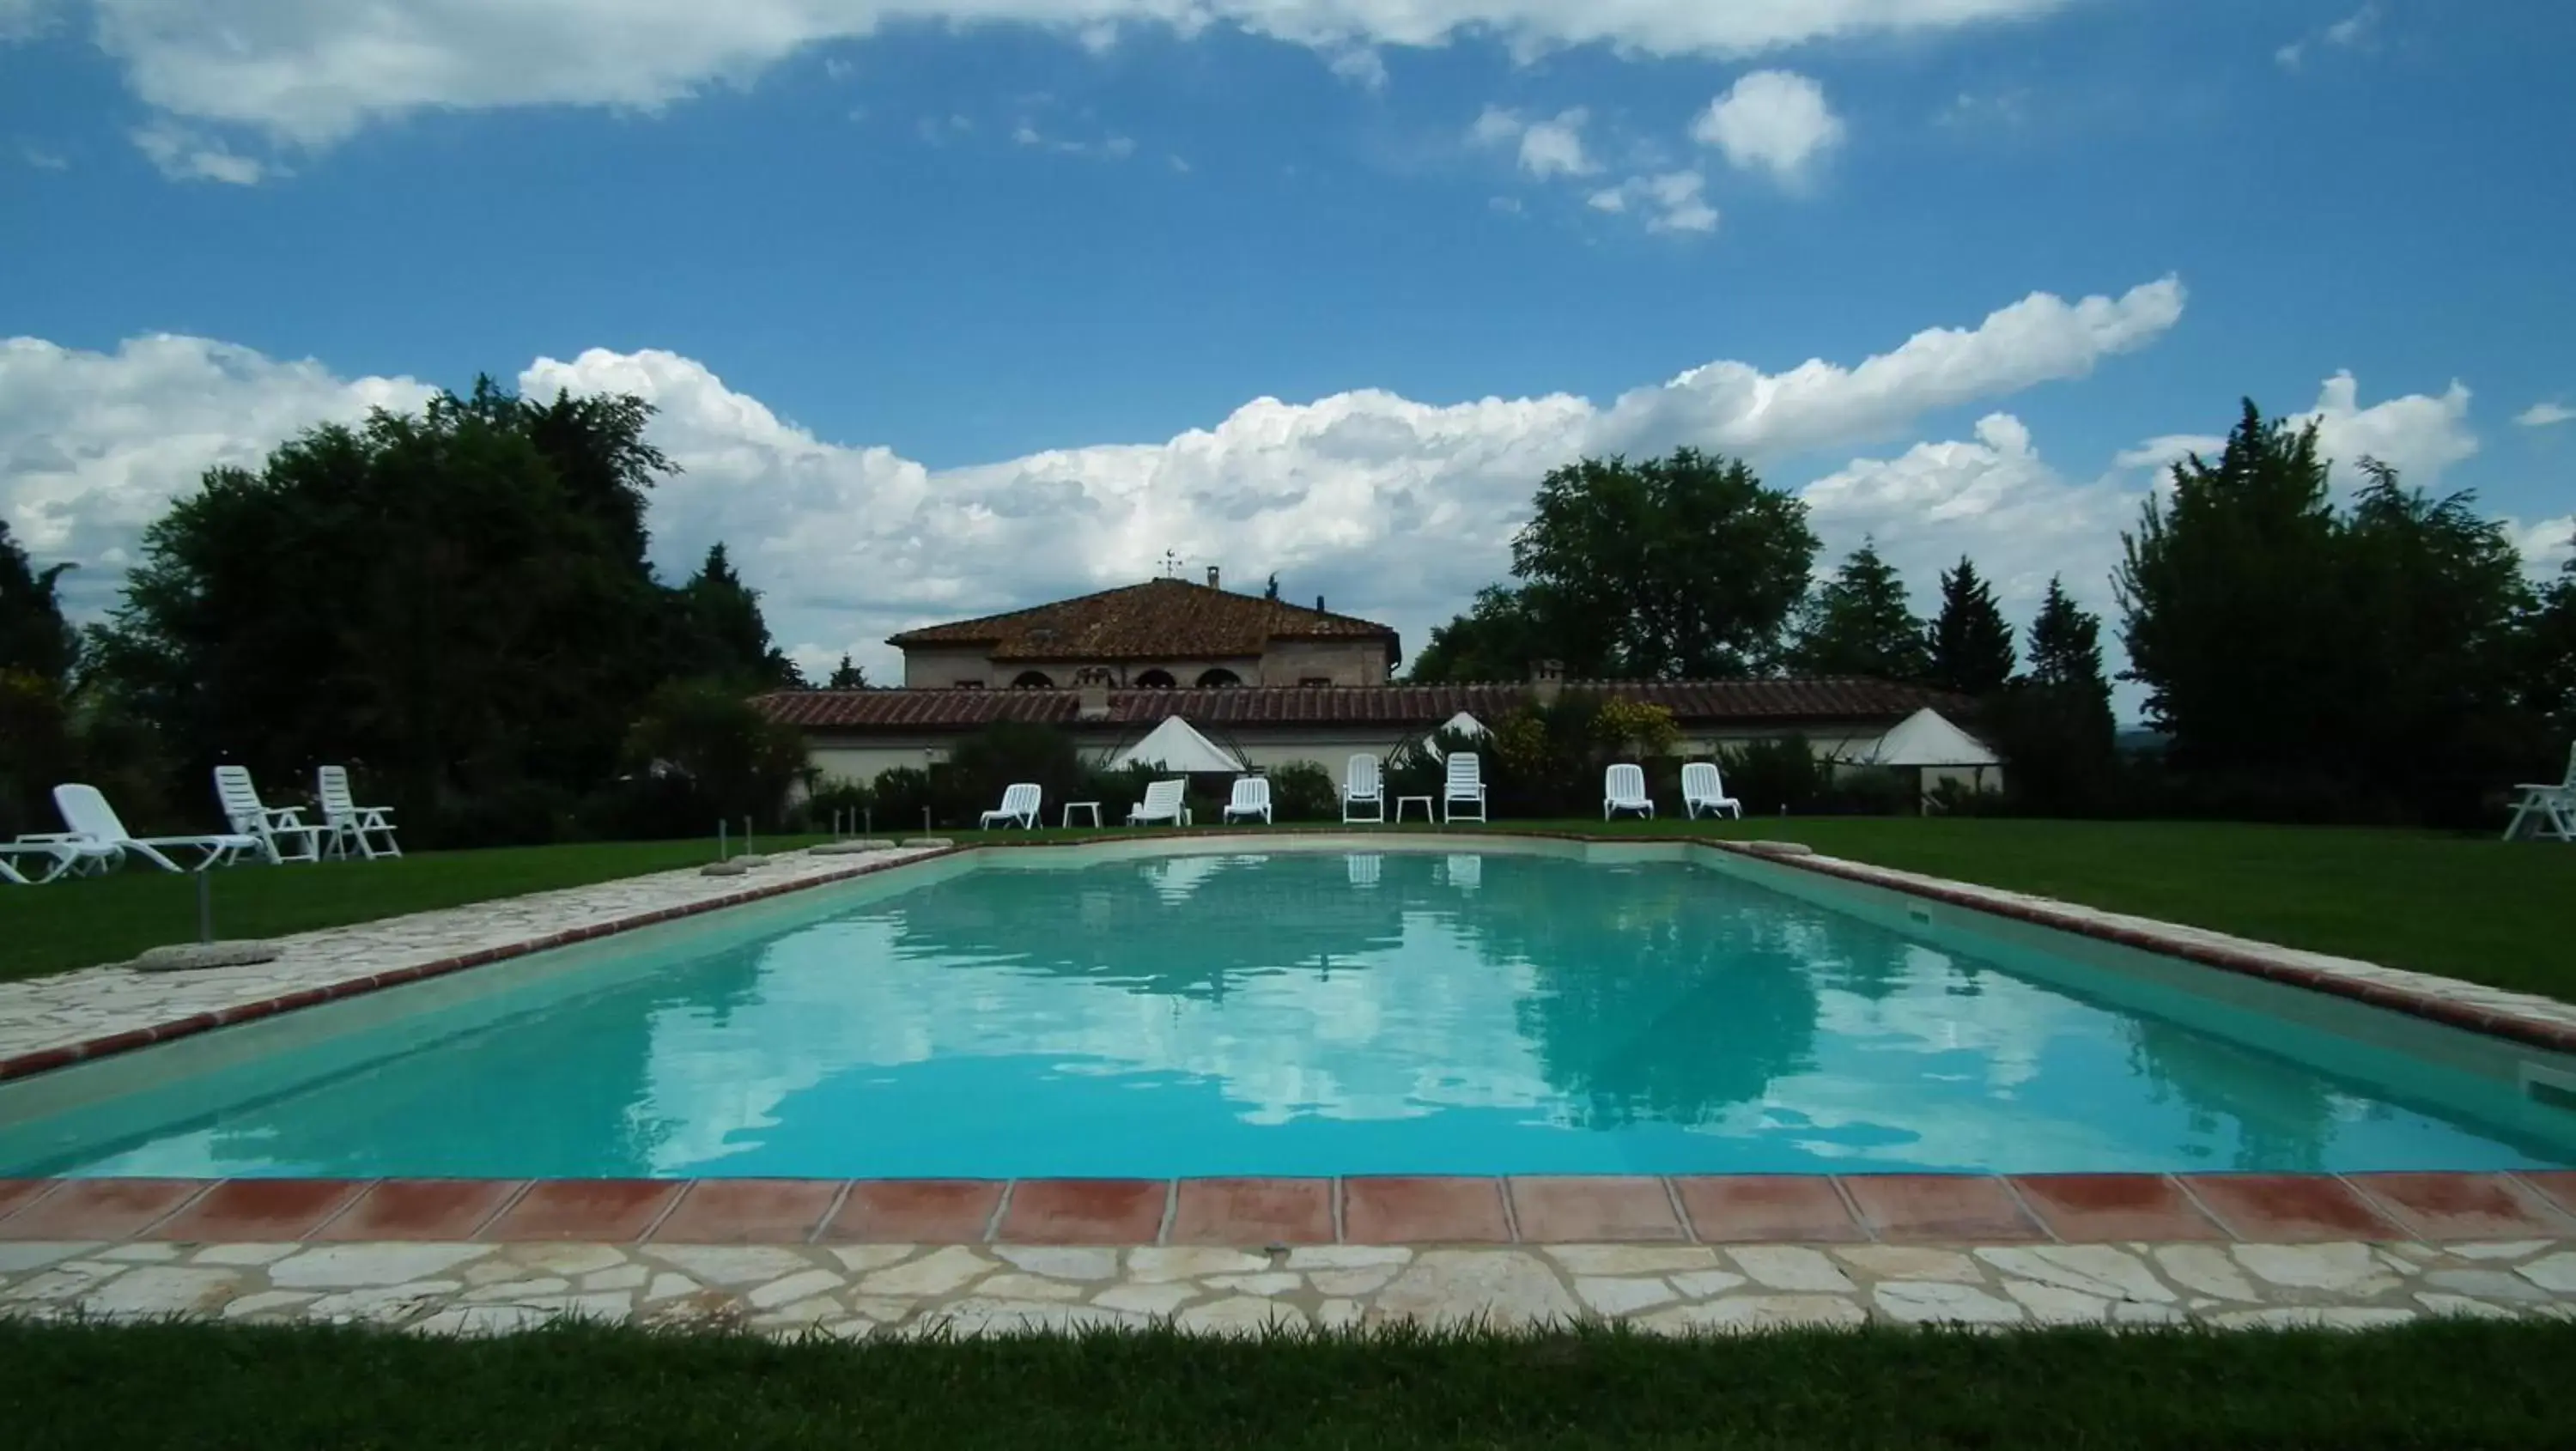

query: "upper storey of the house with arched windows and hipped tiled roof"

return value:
[886, 569, 1401, 690]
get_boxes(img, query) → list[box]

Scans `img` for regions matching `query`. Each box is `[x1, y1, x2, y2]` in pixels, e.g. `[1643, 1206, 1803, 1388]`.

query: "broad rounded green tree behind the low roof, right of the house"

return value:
[1414, 448, 1816, 680]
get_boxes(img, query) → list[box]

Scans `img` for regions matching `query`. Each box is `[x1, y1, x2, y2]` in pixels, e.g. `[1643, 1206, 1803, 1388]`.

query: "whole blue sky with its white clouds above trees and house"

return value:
[0, 0, 2576, 695]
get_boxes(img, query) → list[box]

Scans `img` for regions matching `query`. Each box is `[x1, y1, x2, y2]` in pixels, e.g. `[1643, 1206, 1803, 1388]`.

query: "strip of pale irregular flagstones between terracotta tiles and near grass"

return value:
[0, 1240, 2576, 1340]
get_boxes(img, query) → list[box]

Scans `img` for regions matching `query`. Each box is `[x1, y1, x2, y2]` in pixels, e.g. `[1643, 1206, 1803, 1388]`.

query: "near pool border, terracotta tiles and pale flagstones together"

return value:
[0, 1175, 2576, 1338]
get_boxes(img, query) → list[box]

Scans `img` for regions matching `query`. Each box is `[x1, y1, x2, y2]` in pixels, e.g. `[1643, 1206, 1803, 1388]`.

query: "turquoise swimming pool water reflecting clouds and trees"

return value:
[0, 853, 2576, 1175]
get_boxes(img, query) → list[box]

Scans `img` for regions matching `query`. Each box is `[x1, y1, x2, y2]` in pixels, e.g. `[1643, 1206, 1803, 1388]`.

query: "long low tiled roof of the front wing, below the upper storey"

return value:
[760, 675, 1955, 732]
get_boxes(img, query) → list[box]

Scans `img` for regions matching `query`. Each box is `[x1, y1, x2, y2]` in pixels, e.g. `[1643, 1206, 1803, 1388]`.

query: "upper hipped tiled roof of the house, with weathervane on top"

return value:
[886, 580, 1396, 659]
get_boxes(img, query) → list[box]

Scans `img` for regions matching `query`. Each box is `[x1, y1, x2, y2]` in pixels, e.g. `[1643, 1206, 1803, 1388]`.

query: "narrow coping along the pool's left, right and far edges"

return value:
[0, 825, 2576, 1083]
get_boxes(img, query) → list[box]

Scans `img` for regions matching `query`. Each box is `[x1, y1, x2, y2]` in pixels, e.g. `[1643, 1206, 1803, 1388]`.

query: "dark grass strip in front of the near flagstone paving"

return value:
[0, 1322, 2576, 1451]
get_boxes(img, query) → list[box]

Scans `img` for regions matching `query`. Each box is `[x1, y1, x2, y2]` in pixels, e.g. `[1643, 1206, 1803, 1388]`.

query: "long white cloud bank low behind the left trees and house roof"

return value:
[0, 278, 2182, 670]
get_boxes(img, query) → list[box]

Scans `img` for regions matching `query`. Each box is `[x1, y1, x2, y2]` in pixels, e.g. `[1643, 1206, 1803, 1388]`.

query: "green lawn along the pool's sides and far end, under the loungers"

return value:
[0, 817, 2576, 1000]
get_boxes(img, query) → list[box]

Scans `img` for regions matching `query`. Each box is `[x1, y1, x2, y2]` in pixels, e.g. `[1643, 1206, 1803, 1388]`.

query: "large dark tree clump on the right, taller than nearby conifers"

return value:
[2115, 402, 2537, 820]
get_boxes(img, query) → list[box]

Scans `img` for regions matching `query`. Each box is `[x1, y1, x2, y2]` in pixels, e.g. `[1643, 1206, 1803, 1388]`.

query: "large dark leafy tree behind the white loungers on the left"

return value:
[100, 379, 788, 835]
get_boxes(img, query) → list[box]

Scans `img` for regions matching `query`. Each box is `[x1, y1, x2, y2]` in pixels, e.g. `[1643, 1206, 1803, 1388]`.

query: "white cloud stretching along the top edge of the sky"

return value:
[15, 0, 2066, 157]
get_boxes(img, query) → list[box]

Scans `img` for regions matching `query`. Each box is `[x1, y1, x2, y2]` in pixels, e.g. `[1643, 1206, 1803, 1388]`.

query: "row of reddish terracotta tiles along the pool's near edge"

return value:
[0, 1170, 2576, 1248]
